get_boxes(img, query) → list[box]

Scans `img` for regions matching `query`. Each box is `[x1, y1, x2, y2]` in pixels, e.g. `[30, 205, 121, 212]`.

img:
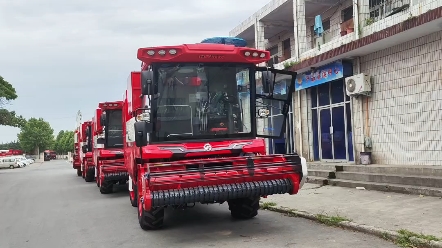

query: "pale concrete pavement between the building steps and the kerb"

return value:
[262, 183, 442, 247]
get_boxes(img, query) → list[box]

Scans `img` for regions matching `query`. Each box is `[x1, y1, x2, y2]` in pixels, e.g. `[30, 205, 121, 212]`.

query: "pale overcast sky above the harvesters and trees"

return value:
[0, 0, 270, 143]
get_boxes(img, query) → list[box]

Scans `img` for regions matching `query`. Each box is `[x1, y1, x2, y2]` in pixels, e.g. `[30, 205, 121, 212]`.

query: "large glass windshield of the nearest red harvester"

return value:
[152, 64, 251, 142]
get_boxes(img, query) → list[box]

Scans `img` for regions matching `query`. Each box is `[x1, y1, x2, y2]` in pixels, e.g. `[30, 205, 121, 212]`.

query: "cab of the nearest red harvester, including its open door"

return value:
[136, 39, 296, 147]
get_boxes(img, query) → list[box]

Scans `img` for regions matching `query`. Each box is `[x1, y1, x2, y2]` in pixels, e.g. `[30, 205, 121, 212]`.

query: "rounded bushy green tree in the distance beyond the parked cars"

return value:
[17, 118, 54, 154]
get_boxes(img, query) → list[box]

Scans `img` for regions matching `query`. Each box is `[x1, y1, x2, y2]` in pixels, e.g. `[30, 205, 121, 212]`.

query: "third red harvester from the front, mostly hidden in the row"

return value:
[81, 120, 95, 182]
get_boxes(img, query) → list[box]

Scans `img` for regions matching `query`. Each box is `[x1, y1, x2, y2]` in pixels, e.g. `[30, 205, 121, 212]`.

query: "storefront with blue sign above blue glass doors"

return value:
[295, 61, 354, 162]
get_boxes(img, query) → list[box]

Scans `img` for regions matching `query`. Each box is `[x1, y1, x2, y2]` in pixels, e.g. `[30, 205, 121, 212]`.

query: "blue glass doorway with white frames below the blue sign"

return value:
[310, 79, 354, 162]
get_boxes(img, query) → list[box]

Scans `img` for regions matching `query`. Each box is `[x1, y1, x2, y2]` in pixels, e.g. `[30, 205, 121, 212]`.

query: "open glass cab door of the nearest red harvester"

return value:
[255, 67, 297, 139]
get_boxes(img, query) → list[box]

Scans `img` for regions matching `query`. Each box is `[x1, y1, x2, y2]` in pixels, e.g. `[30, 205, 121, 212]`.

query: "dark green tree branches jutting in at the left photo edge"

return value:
[0, 76, 26, 128]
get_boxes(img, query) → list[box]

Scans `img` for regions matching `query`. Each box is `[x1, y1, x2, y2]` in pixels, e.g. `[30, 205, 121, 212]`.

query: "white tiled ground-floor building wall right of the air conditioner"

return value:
[360, 31, 442, 165]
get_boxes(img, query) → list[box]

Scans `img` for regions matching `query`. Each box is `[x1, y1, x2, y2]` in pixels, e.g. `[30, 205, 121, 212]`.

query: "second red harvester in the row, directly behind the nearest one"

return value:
[94, 101, 129, 194]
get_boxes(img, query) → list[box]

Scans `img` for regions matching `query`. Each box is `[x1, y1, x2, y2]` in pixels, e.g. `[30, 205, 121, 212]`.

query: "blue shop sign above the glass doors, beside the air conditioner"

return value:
[295, 61, 344, 91]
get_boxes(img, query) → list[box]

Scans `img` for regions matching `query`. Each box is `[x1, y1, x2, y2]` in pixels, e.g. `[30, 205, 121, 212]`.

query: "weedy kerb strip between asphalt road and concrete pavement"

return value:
[260, 204, 442, 248]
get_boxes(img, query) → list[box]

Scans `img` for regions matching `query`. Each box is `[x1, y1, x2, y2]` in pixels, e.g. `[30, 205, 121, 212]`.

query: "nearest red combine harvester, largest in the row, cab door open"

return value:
[125, 38, 307, 230]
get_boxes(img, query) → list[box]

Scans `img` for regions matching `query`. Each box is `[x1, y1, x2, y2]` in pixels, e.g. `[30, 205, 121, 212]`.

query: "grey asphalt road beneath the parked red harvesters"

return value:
[0, 161, 397, 248]
